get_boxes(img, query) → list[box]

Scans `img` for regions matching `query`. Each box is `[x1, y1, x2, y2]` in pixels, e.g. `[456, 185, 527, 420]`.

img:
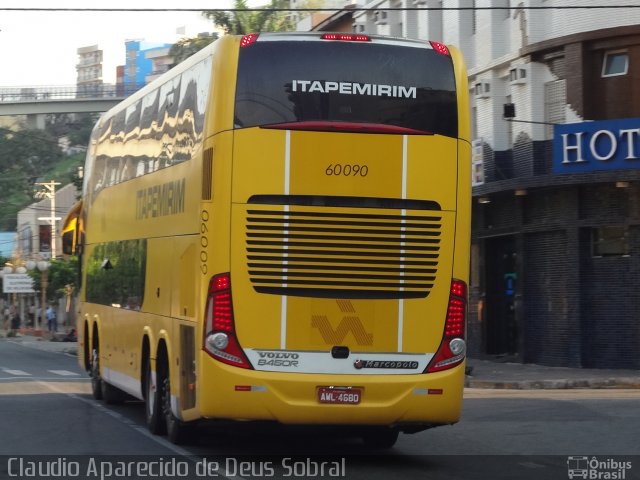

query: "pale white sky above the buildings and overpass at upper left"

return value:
[0, 0, 242, 88]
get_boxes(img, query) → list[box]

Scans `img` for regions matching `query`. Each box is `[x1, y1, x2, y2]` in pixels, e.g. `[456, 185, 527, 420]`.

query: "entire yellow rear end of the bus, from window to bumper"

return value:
[200, 35, 470, 431]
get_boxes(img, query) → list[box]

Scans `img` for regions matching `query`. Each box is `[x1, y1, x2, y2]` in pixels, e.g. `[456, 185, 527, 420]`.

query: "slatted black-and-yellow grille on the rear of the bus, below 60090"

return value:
[246, 207, 442, 298]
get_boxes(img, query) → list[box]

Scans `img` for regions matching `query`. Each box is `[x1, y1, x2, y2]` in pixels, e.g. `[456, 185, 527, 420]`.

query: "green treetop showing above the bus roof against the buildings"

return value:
[203, 0, 295, 35]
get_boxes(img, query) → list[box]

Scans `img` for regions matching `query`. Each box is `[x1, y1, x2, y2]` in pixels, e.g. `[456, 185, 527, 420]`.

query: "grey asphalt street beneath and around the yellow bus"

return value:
[0, 339, 640, 480]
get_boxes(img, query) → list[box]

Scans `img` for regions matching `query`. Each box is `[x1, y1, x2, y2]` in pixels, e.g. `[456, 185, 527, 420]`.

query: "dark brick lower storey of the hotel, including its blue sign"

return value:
[469, 118, 640, 368]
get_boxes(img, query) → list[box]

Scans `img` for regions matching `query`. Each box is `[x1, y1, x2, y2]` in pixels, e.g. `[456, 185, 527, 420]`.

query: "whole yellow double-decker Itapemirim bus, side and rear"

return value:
[64, 33, 471, 447]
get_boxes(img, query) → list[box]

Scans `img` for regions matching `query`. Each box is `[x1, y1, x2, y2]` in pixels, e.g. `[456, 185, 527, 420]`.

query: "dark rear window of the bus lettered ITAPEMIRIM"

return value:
[235, 41, 458, 137]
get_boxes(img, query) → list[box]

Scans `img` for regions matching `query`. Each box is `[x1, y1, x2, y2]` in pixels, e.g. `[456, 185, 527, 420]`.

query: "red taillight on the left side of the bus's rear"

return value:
[203, 273, 251, 368]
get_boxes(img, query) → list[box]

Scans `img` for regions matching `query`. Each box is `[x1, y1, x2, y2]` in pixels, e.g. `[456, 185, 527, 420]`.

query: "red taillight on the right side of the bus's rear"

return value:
[427, 279, 467, 373]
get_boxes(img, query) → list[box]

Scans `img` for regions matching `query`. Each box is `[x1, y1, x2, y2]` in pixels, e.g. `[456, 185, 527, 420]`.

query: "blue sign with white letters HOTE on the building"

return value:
[553, 118, 640, 173]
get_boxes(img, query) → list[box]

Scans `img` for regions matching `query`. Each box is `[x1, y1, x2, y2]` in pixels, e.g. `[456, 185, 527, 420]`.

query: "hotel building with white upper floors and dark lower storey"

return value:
[302, 0, 640, 368]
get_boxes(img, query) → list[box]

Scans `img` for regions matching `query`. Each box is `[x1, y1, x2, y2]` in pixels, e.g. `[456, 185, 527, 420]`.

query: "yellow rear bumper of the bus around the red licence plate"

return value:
[198, 359, 464, 431]
